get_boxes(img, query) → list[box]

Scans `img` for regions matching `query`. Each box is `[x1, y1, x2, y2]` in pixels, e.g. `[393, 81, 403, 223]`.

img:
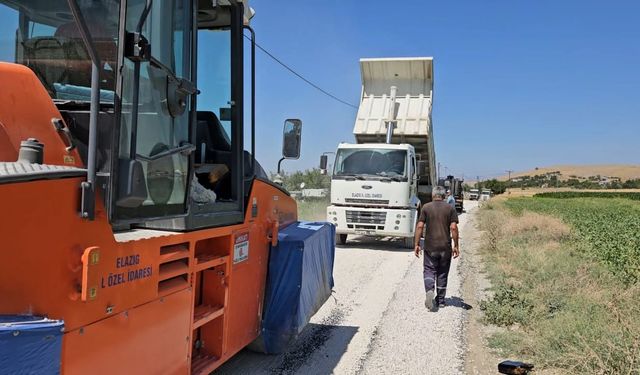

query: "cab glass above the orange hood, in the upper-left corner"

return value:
[0, 0, 120, 102]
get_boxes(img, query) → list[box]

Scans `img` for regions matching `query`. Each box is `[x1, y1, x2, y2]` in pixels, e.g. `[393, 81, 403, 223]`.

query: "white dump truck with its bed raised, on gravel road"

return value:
[321, 57, 437, 247]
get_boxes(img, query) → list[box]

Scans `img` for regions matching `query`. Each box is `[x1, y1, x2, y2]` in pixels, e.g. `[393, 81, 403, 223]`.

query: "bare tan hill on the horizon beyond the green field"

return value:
[498, 164, 640, 181]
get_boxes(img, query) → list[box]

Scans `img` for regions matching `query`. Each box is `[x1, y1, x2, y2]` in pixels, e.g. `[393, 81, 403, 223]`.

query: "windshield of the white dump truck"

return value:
[333, 148, 407, 177]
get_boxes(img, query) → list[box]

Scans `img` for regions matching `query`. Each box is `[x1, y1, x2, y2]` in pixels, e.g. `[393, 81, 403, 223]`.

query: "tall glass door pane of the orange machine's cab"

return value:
[115, 0, 192, 220]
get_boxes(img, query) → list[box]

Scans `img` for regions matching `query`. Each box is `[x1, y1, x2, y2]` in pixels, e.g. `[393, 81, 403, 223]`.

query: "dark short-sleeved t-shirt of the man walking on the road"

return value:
[418, 201, 458, 251]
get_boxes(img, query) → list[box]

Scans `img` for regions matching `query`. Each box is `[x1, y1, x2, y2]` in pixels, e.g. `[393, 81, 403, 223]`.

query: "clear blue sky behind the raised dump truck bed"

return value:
[244, 0, 640, 178]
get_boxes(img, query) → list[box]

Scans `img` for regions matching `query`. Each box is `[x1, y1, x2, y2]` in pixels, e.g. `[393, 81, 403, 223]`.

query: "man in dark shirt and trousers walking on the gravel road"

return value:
[414, 186, 460, 311]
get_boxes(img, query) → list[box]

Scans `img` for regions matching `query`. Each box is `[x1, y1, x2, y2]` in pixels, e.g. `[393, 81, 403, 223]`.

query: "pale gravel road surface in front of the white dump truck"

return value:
[216, 202, 475, 374]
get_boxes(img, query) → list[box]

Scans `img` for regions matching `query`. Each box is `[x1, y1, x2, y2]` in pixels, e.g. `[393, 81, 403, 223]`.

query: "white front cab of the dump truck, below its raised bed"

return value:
[327, 143, 420, 245]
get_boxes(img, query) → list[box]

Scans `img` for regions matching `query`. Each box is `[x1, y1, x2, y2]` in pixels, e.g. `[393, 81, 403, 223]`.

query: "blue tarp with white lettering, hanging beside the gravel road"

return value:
[254, 222, 336, 354]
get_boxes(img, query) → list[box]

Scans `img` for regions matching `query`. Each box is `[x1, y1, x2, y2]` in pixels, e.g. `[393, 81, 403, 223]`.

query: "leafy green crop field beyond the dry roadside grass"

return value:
[505, 192, 640, 283]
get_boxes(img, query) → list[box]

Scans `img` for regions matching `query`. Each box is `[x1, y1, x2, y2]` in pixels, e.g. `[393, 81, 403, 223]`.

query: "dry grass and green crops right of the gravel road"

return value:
[480, 198, 640, 374]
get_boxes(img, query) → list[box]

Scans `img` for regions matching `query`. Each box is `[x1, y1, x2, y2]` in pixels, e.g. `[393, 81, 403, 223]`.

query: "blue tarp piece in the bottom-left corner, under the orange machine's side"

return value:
[0, 315, 64, 374]
